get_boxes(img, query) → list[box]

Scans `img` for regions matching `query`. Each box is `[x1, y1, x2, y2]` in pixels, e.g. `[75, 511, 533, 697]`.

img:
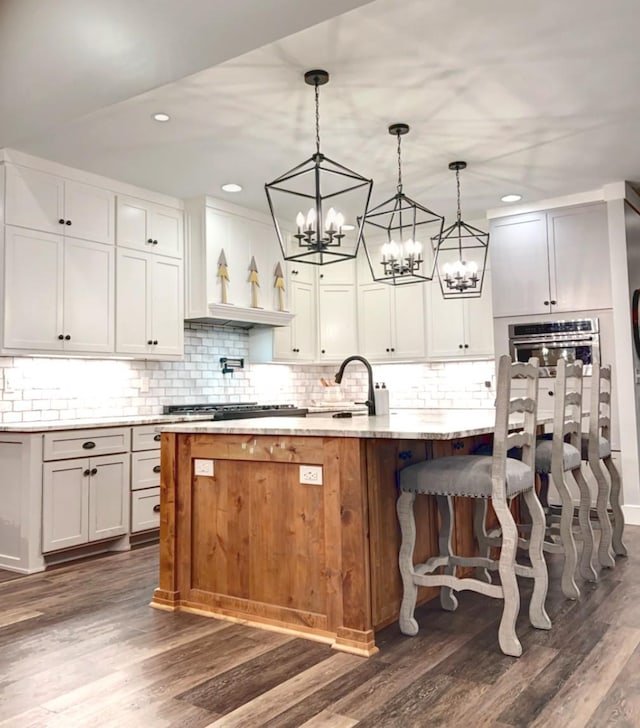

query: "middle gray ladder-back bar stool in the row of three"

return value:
[521, 359, 598, 599]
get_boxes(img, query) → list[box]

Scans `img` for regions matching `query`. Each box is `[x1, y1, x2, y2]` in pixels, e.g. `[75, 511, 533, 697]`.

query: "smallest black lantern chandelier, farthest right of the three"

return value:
[434, 162, 489, 298]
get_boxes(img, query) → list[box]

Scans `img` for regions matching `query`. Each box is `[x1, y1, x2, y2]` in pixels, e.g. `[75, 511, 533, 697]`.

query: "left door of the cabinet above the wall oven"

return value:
[489, 212, 552, 316]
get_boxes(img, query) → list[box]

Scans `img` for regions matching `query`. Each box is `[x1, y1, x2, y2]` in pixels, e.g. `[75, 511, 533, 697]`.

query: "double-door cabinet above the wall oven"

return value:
[489, 203, 611, 316]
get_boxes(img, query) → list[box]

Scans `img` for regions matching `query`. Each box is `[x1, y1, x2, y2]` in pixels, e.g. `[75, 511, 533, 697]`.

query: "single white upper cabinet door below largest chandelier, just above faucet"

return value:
[318, 286, 358, 361]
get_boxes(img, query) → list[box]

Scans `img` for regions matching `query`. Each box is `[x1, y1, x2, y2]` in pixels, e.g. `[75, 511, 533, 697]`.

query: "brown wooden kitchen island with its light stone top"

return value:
[151, 410, 510, 655]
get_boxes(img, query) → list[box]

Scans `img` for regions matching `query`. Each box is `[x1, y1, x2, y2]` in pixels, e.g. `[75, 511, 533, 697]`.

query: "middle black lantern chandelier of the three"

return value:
[362, 124, 444, 286]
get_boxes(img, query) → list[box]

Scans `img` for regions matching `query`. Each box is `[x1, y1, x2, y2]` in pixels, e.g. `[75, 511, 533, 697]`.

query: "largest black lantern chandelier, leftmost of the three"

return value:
[265, 70, 373, 265]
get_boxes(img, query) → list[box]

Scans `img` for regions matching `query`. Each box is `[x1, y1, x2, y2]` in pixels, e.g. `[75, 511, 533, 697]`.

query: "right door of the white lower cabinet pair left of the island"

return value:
[88, 454, 129, 541]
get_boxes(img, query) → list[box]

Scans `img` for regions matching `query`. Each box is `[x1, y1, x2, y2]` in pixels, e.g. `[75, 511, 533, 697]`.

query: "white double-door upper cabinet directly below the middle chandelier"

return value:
[358, 255, 426, 361]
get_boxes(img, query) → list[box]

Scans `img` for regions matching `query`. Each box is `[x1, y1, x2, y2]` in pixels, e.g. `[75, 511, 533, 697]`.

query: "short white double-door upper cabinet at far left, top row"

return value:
[5, 164, 115, 243]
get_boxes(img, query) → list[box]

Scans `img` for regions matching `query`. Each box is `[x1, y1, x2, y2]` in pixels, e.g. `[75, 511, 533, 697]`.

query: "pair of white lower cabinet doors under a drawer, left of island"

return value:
[42, 454, 129, 553]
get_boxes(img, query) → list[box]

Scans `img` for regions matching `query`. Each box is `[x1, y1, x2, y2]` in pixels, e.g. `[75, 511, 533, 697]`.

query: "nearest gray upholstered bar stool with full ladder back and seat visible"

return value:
[397, 356, 551, 657]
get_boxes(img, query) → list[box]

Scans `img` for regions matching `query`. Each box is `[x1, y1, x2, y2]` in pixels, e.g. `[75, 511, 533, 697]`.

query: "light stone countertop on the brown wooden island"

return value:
[156, 409, 540, 440]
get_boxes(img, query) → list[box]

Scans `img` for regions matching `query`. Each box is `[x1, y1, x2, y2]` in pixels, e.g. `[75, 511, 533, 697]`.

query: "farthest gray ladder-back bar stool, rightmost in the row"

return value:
[582, 362, 627, 568]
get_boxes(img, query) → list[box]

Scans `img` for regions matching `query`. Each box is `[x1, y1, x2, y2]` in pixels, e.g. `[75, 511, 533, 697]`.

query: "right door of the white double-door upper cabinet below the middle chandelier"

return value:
[392, 283, 426, 359]
